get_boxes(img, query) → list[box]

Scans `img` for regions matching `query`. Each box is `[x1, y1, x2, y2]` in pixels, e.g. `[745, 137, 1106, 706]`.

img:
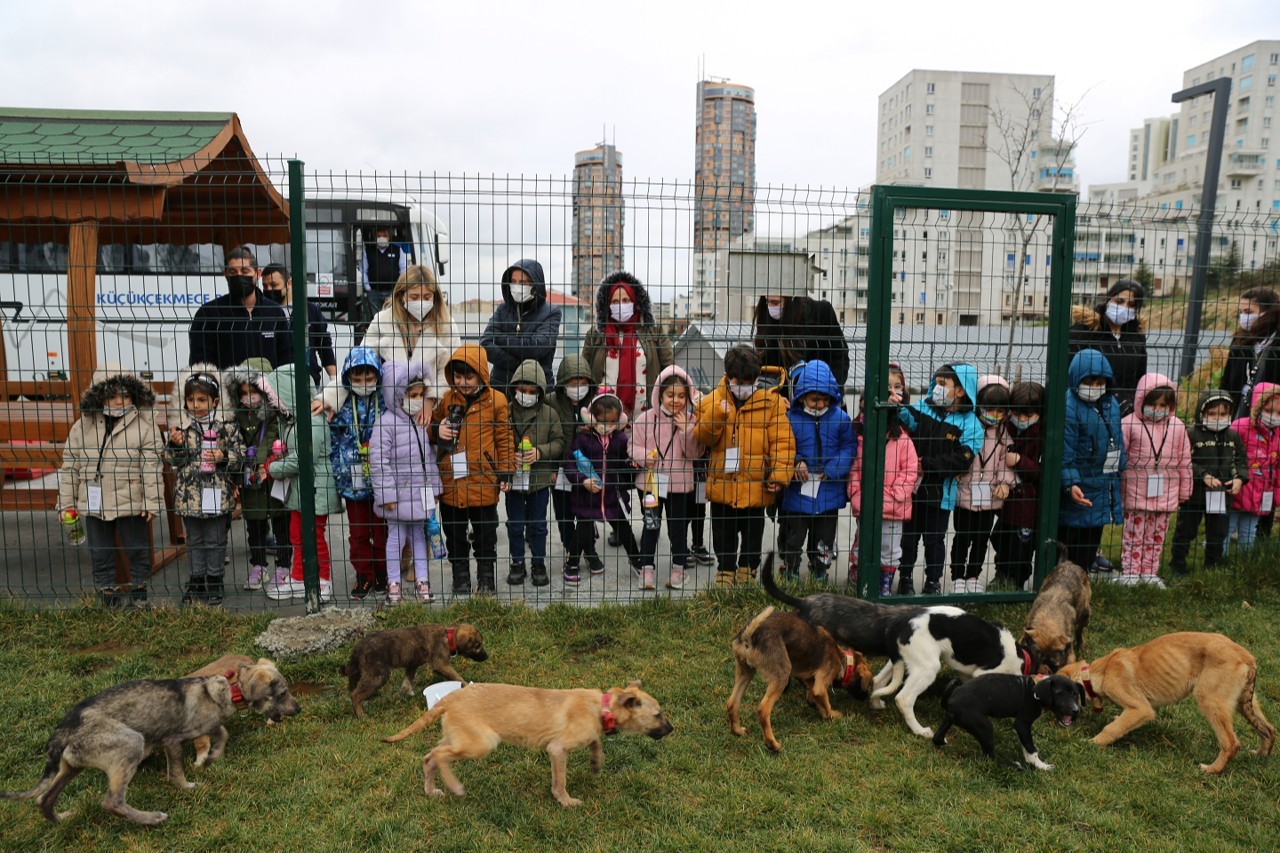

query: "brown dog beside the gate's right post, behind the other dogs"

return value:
[1023, 560, 1093, 675]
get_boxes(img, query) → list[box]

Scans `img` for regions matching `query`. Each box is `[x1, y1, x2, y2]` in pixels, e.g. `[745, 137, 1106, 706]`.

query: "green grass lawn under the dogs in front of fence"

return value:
[0, 546, 1280, 850]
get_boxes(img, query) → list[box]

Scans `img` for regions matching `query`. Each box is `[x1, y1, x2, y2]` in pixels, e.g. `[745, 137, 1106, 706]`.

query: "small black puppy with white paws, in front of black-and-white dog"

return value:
[933, 674, 1084, 770]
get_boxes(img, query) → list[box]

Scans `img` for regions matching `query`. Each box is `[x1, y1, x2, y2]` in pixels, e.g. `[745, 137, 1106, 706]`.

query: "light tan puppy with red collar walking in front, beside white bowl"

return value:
[383, 681, 671, 806]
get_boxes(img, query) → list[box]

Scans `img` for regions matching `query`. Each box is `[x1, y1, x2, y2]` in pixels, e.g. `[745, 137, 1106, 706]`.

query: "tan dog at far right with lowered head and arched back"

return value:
[1062, 631, 1276, 774]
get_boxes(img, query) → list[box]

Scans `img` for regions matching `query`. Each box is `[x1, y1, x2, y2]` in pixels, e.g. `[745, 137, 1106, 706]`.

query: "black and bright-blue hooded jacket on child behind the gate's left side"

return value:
[899, 364, 987, 511]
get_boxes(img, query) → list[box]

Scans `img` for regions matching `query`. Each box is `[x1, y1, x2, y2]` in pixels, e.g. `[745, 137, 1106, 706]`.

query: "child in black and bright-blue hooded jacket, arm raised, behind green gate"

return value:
[897, 364, 987, 596]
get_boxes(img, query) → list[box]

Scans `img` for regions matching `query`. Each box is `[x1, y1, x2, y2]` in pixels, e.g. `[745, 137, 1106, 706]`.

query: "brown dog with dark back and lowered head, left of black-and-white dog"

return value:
[724, 607, 872, 752]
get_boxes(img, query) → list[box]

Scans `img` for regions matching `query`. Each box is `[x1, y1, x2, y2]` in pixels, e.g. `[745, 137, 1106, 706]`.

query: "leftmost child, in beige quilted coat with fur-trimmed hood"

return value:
[58, 370, 164, 607]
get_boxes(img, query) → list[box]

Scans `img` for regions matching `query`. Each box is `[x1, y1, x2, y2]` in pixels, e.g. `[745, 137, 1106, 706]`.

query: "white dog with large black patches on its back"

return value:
[870, 606, 1034, 738]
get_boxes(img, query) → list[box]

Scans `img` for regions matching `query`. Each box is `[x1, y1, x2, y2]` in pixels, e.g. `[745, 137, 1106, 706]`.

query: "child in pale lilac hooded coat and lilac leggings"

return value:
[369, 361, 443, 605]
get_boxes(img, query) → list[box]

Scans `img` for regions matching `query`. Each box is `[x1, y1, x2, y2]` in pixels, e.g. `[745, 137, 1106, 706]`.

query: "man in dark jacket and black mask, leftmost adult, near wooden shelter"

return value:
[187, 246, 293, 370]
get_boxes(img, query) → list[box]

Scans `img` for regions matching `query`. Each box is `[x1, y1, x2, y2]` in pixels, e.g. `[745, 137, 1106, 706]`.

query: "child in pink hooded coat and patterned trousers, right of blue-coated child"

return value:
[1119, 373, 1194, 587]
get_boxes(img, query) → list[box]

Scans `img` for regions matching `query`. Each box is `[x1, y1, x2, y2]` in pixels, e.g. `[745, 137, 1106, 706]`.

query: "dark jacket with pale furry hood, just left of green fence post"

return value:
[223, 359, 293, 521]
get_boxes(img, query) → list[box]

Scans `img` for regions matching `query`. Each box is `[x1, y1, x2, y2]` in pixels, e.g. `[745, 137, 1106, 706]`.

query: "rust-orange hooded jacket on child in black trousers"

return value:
[431, 343, 515, 507]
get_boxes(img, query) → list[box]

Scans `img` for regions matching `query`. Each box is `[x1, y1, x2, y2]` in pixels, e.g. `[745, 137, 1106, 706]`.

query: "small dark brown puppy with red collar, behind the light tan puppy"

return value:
[339, 622, 489, 719]
